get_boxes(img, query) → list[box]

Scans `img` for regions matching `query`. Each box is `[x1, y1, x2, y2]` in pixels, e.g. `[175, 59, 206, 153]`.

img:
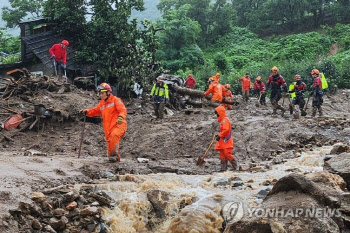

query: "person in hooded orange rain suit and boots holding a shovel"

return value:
[215, 106, 237, 171]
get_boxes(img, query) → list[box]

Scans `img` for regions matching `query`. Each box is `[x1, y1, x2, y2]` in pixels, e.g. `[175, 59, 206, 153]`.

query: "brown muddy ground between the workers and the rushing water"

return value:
[0, 81, 350, 232]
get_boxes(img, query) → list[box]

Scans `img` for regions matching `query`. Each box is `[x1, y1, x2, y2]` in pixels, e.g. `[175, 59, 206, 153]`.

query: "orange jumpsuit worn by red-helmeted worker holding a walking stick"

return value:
[86, 94, 127, 160]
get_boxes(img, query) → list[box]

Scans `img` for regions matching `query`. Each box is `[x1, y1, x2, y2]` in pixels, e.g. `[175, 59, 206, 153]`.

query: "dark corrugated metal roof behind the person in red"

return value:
[22, 31, 92, 74]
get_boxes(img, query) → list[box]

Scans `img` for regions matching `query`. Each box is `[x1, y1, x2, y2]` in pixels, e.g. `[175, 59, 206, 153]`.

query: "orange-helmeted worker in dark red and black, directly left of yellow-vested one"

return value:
[266, 66, 288, 116]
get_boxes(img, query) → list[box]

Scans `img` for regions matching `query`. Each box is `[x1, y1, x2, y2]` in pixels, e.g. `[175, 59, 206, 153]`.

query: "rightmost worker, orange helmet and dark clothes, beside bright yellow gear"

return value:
[310, 69, 323, 117]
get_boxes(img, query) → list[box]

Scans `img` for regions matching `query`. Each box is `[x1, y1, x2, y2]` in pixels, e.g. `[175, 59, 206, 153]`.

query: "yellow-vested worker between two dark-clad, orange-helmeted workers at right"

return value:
[289, 74, 306, 116]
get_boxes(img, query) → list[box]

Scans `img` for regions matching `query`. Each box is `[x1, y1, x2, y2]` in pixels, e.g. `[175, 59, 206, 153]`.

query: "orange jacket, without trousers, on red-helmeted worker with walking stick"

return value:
[86, 94, 127, 140]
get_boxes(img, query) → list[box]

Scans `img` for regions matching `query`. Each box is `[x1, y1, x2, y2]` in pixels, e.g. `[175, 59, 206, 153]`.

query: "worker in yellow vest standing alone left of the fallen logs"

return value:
[150, 77, 169, 119]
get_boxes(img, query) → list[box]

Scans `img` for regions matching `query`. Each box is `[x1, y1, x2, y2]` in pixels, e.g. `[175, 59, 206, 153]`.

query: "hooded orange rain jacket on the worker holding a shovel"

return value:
[215, 106, 233, 150]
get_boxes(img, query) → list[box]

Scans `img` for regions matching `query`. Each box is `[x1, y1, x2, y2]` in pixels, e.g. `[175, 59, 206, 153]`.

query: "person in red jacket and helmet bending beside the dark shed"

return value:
[49, 40, 69, 78]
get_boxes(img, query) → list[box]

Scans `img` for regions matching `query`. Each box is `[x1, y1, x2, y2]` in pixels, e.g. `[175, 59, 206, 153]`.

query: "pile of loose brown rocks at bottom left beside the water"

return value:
[10, 185, 114, 233]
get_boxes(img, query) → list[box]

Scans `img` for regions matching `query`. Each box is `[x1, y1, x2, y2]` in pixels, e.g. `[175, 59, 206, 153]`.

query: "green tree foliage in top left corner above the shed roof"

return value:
[1, 0, 44, 28]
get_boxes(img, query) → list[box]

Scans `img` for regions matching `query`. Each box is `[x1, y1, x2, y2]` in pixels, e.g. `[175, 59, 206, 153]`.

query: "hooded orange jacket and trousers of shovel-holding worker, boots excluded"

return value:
[215, 106, 235, 161]
